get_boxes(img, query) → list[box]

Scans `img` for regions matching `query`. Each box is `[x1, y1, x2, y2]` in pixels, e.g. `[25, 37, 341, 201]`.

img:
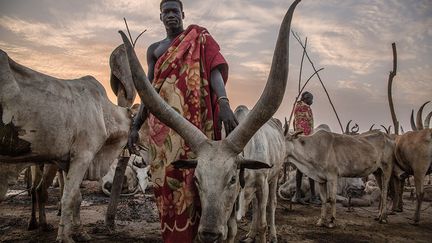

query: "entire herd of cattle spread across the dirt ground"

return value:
[0, 0, 432, 242]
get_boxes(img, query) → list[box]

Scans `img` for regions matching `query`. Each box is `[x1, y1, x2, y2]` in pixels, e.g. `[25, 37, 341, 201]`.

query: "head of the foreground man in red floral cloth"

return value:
[160, 0, 184, 29]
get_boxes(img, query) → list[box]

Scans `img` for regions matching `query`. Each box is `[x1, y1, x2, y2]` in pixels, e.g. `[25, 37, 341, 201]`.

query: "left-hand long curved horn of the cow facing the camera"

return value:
[119, 31, 207, 152]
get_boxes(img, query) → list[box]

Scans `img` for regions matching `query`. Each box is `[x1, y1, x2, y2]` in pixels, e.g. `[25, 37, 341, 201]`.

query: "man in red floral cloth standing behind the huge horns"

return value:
[129, 0, 238, 242]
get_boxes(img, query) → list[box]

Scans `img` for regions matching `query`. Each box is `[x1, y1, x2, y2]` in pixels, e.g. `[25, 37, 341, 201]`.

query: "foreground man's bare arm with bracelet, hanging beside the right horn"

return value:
[210, 68, 238, 135]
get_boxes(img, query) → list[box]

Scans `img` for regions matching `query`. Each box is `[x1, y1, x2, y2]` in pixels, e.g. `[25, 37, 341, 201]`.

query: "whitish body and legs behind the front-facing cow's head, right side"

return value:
[235, 106, 285, 242]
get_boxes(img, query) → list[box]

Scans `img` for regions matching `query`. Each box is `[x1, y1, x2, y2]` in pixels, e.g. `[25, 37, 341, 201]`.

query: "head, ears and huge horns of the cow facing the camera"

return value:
[120, 0, 300, 242]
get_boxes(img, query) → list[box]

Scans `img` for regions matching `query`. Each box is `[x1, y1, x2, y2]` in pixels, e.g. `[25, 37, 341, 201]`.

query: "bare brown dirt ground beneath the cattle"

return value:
[0, 178, 432, 243]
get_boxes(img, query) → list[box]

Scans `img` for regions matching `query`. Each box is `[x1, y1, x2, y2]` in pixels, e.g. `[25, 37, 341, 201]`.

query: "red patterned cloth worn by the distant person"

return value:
[294, 100, 313, 135]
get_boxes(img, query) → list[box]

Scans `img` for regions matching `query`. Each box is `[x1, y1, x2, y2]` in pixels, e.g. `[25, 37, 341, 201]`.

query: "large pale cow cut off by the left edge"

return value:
[0, 50, 131, 242]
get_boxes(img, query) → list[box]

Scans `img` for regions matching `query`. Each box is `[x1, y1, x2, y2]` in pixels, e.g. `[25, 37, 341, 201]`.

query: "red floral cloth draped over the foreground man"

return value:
[144, 25, 228, 243]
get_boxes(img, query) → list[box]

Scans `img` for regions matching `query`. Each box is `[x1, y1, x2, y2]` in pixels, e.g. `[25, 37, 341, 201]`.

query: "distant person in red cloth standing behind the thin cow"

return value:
[291, 91, 321, 204]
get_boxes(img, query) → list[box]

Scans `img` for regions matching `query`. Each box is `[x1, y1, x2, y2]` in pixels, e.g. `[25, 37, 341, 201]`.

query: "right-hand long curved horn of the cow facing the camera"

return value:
[226, 0, 300, 153]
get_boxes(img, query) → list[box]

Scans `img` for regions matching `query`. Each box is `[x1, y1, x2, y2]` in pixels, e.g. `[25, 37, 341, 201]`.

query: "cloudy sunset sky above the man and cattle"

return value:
[0, 0, 432, 132]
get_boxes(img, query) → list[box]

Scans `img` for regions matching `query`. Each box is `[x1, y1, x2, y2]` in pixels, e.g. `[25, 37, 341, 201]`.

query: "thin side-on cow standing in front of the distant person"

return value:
[286, 130, 394, 228]
